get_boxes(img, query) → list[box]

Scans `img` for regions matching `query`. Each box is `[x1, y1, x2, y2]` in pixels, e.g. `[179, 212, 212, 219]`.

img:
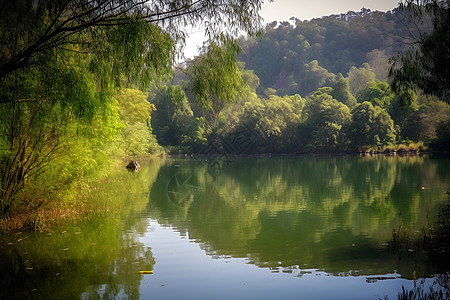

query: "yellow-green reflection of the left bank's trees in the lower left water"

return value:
[0, 162, 161, 299]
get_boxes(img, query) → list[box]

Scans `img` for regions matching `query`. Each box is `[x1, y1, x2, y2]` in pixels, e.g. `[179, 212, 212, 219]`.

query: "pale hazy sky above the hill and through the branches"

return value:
[184, 0, 399, 58]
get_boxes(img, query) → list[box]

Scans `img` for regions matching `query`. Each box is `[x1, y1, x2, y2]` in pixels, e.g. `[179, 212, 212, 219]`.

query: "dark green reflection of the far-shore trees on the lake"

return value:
[147, 156, 450, 278]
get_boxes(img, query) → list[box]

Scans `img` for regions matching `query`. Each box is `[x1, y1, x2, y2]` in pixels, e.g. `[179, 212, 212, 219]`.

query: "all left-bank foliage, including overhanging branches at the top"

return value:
[0, 0, 268, 213]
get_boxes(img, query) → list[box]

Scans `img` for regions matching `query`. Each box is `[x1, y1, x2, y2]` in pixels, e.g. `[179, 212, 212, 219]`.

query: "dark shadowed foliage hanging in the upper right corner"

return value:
[389, 0, 450, 106]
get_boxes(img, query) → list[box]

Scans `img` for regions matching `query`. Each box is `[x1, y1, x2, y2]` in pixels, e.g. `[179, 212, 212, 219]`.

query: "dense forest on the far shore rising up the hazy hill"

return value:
[148, 8, 450, 154]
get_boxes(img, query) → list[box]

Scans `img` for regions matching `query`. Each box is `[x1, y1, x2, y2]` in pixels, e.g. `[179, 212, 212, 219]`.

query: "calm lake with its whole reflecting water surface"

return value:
[0, 156, 450, 299]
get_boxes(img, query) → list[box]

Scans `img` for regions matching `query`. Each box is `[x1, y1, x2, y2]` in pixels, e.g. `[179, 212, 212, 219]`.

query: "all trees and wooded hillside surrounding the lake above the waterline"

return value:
[0, 0, 450, 215]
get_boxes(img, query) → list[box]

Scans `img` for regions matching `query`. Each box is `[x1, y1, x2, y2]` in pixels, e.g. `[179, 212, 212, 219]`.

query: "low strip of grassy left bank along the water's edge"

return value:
[0, 157, 164, 232]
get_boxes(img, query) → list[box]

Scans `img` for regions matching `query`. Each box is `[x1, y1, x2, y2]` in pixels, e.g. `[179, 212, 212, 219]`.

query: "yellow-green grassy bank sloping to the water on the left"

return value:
[0, 156, 164, 232]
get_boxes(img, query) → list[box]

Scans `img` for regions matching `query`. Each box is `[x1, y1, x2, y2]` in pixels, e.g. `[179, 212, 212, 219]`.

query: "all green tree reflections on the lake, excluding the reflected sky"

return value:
[0, 156, 450, 298]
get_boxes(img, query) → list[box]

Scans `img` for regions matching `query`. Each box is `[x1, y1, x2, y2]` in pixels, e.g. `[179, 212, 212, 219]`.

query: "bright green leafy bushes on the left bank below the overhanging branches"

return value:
[0, 11, 173, 212]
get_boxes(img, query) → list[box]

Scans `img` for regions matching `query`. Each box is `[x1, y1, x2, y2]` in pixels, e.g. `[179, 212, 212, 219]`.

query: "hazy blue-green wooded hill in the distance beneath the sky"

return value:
[239, 8, 409, 96]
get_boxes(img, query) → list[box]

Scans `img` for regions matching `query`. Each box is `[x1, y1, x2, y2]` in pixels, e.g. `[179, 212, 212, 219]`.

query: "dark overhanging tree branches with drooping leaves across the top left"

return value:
[0, 0, 262, 85]
